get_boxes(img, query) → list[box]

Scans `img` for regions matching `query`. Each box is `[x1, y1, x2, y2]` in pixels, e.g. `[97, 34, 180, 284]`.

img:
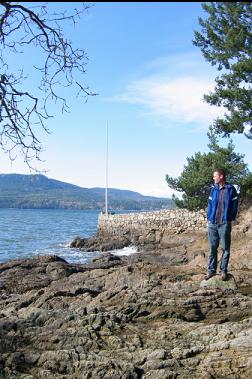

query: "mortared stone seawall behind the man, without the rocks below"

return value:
[98, 209, 207, 237]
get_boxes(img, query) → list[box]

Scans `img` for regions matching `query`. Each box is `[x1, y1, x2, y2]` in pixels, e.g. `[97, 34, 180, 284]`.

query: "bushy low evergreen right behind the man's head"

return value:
[166, 129, 252, 210]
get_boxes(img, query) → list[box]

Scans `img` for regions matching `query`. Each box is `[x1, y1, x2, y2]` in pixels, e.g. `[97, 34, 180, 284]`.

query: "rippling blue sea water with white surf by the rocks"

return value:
[0, 209, 136, 263]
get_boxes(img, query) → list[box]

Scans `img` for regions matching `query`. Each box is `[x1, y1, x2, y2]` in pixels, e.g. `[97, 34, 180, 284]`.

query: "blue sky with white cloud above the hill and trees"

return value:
[0, 2, 252, 197]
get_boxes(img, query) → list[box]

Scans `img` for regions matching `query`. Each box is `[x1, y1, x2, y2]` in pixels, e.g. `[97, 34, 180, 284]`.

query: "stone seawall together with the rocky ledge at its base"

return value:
[71, 209, 207, 251]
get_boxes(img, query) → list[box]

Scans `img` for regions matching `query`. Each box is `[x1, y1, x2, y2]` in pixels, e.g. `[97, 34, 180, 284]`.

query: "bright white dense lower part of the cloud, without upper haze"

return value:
[113, 76, 223, 127]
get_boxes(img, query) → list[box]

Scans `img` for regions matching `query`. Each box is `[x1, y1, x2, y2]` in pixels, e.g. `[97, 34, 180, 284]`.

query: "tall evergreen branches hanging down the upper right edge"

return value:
[193, 2, 252, 139]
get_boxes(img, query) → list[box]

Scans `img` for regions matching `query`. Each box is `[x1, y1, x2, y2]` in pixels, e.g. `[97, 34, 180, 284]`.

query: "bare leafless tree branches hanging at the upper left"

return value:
[0, 2, 96, 171]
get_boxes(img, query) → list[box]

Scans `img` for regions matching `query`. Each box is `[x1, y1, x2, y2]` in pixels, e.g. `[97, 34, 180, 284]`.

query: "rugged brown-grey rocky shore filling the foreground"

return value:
[0, 208, 252, 379]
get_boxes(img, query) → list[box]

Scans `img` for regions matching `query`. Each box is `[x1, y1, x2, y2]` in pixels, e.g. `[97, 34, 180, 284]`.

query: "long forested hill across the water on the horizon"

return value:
[0, 174, 174, 210]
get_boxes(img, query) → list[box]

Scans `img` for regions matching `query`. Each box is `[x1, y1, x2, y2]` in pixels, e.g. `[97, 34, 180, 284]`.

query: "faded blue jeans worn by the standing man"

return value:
[208, 222, 231, 274]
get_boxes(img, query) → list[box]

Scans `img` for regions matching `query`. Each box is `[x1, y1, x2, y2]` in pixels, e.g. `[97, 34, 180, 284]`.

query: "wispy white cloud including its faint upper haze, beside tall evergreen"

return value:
[109, 51, 224, 128]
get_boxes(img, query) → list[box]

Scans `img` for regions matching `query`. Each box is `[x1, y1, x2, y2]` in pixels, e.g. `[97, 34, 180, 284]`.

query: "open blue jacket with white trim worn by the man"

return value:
[207, 183, 238, 223]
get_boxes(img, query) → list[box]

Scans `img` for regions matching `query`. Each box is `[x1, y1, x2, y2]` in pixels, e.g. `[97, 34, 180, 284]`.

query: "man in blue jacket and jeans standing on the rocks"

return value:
[205, 169, 238, 280]
